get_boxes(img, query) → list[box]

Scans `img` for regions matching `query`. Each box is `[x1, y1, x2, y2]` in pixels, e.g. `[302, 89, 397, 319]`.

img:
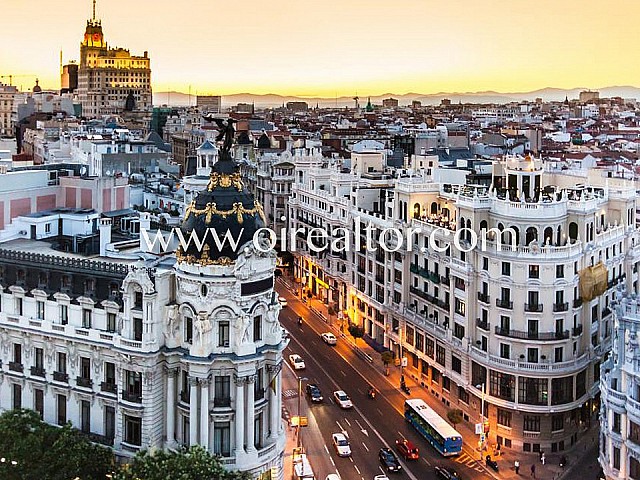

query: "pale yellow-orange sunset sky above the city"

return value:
[0, 0, 640, 97]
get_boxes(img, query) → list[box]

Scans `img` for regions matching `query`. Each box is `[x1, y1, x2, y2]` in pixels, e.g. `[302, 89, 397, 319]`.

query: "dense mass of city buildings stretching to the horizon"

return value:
[0, 1, 640, 479]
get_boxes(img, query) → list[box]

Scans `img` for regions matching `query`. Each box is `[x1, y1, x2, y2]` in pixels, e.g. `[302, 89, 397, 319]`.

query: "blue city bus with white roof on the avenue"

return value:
[404, 398, 462, 457]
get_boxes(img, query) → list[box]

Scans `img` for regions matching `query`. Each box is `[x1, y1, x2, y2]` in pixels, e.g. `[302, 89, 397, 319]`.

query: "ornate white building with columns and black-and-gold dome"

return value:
[0, 156, 287, 480]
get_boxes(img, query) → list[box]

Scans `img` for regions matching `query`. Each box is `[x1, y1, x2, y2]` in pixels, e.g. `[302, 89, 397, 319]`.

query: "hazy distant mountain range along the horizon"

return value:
[153, 86, 640, 108]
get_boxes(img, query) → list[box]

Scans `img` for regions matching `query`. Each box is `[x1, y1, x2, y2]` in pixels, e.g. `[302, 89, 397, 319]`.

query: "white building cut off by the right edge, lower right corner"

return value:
[599, 286, 640, 480]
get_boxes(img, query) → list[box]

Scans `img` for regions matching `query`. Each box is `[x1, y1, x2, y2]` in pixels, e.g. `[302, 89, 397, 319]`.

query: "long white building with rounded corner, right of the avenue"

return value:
[289, 152, 639, 452]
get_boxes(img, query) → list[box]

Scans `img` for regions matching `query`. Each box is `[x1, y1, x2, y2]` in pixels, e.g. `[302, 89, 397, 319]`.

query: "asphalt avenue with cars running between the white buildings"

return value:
[278, 288, 490, 480]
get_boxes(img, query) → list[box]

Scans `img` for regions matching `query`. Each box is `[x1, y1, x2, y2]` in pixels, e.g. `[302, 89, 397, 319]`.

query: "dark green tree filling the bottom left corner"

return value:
[0, 410, 113, 480]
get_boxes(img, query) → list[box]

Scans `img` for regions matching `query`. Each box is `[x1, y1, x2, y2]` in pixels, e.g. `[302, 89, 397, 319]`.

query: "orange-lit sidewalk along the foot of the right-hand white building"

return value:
[281, 279, 599, 480]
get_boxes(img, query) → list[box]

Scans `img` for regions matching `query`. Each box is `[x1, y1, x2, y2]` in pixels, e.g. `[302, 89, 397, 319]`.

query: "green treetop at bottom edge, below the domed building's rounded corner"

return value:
[113, 445, 251, 480]
